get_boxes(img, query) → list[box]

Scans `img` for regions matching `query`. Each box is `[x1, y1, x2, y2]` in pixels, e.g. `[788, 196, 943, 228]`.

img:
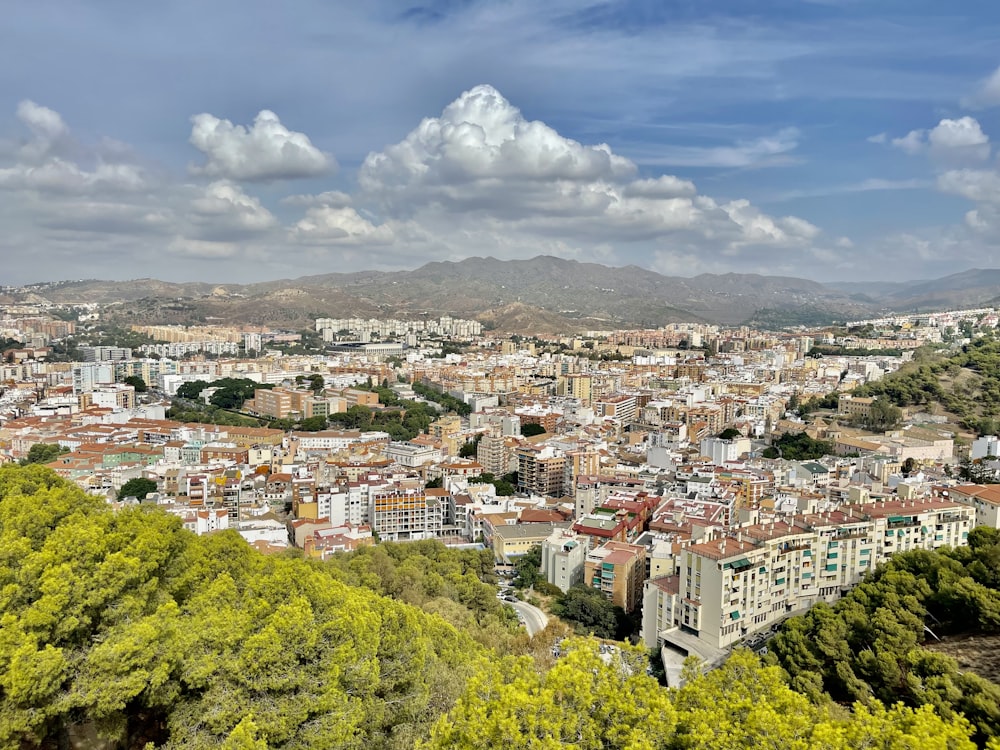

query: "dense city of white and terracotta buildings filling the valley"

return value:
[0, 305, 1000, 678]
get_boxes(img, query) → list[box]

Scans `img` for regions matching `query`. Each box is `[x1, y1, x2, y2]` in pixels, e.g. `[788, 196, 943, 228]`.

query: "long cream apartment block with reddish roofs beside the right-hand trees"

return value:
[643, 498, 975, 649]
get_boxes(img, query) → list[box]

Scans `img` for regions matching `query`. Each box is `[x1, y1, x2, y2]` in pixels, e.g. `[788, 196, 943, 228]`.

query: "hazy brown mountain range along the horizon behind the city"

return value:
[7, 256, 1000, 332]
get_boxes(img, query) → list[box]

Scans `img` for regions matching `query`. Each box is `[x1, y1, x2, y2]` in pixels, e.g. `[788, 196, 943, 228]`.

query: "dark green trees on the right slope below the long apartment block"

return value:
[768, 527, 1000, 740]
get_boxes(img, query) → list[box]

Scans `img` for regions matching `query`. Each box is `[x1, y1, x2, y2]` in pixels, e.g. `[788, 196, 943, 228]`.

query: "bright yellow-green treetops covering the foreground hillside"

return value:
[0, 466, 975, 750]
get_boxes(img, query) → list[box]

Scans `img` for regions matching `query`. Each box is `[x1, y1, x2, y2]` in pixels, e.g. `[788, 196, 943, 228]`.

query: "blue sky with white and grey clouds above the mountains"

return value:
[0, 0, 1000, 285]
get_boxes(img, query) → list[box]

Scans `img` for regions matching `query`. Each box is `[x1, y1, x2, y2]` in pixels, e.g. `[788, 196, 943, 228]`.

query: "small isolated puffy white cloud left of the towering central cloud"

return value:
[190, 109, 336, 182]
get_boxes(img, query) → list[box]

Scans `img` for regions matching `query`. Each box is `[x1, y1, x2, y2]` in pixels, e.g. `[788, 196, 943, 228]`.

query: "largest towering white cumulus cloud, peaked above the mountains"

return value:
[359, 86, 832, 262]
